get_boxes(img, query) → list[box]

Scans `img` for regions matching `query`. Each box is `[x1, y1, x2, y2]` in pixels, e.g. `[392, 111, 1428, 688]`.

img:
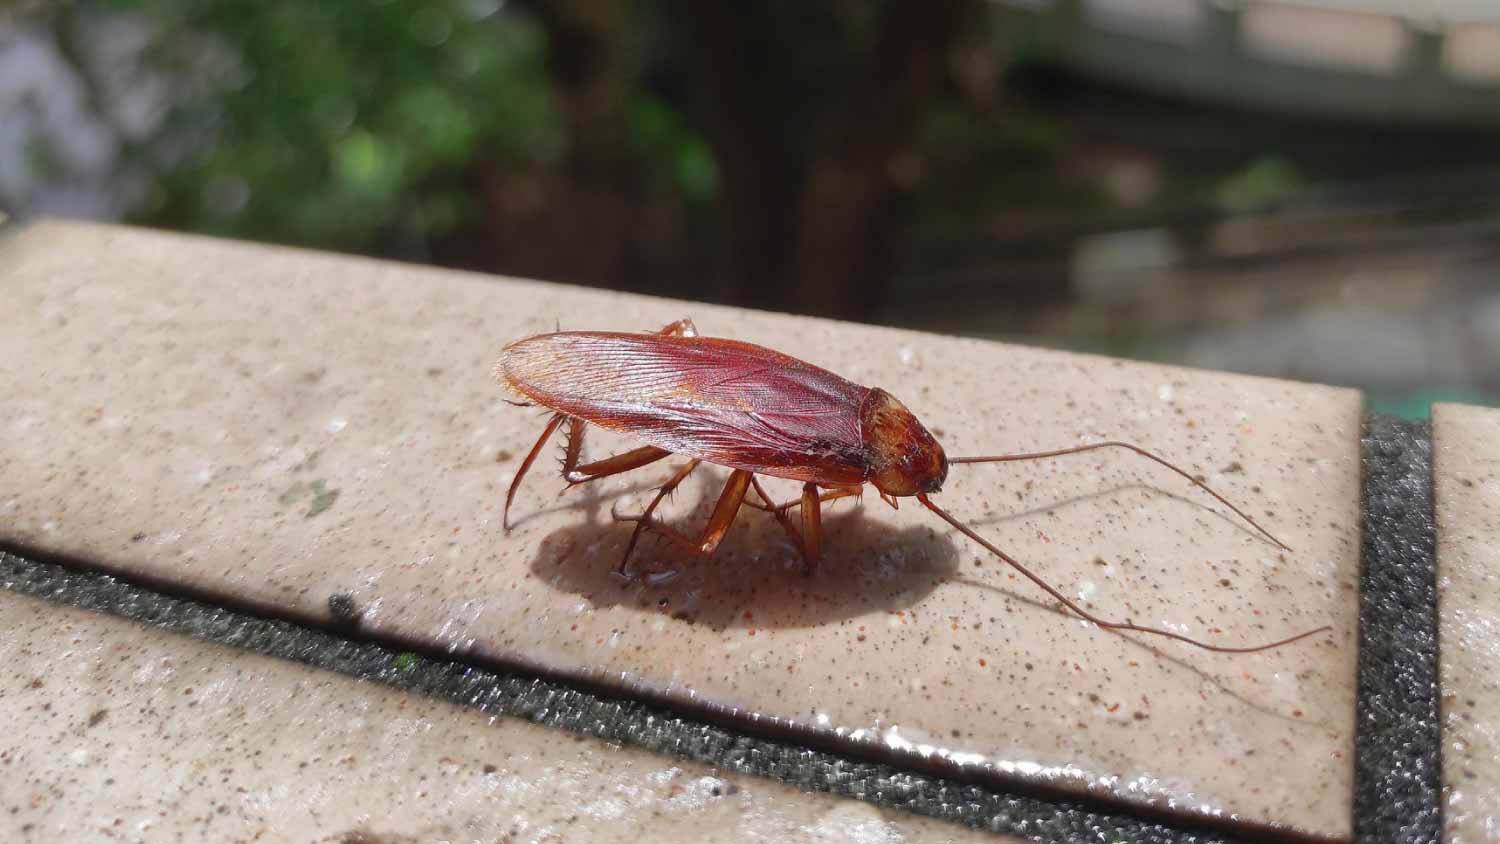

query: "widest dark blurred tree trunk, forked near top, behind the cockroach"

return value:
[674, 0, 980, 318]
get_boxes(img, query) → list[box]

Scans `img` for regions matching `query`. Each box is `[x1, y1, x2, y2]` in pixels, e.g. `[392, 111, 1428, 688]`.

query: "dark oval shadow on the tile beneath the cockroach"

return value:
[531, 472, 960, 630]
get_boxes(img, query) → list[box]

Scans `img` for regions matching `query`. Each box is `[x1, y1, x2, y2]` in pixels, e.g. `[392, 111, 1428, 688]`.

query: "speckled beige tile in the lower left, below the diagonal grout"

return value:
[0, 589, 1014, 844]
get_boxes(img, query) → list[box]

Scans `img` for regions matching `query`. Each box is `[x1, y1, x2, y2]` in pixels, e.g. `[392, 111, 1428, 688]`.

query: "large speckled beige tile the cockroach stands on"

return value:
[0, 223, 1361, 838]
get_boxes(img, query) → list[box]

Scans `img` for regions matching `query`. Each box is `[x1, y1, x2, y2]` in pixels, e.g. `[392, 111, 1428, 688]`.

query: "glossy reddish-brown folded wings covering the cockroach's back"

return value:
[495, 331, 870, 486]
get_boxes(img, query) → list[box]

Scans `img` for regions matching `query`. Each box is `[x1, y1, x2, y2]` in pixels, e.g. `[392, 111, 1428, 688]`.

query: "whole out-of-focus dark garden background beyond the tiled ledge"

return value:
[0, 0, 1500, 412]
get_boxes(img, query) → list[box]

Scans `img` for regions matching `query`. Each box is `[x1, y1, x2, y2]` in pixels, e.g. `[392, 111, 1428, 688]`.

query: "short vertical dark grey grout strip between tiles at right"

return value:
[1355, 417, 1443, 844]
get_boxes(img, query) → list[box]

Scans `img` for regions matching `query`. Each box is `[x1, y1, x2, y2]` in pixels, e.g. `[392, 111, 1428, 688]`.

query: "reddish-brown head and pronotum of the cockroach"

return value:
[860, 387, 948, 496]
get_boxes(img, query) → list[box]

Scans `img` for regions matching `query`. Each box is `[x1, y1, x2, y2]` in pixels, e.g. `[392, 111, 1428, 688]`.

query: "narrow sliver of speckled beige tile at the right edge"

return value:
[1433, 405, 1500, 844]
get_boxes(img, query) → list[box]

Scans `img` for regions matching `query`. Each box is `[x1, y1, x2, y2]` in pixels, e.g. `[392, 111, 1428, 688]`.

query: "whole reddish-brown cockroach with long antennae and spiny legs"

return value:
[495, 319, 1332, 654]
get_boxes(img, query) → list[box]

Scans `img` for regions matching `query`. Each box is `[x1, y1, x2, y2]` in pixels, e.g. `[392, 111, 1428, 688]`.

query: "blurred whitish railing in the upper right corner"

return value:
[995, 0, 1500, 124]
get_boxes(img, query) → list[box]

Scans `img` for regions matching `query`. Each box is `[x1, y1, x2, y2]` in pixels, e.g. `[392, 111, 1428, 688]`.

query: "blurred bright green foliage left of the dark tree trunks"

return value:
[116, 0, 563, 250]
